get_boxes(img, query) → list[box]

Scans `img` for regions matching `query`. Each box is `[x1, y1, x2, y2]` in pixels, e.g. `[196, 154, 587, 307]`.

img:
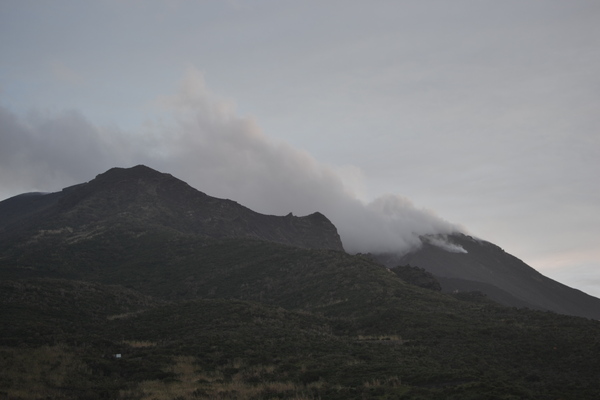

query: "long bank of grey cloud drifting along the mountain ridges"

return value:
[0, 69, 461, 252]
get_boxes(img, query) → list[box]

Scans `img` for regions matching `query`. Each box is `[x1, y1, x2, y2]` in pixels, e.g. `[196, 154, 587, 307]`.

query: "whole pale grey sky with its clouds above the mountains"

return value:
[0, 0, 600, 296]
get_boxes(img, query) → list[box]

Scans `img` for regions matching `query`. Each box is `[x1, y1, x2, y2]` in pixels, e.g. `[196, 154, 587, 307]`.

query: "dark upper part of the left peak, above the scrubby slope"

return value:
[0, 165, 343, 251]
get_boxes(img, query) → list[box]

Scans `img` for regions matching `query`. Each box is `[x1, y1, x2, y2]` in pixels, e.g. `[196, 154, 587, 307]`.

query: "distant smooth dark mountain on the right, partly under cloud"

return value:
[377, 233, 600, 320]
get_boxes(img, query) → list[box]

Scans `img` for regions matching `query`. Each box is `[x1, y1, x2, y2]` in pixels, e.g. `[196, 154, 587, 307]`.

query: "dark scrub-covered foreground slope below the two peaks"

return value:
[0, 164, 600, 399]
